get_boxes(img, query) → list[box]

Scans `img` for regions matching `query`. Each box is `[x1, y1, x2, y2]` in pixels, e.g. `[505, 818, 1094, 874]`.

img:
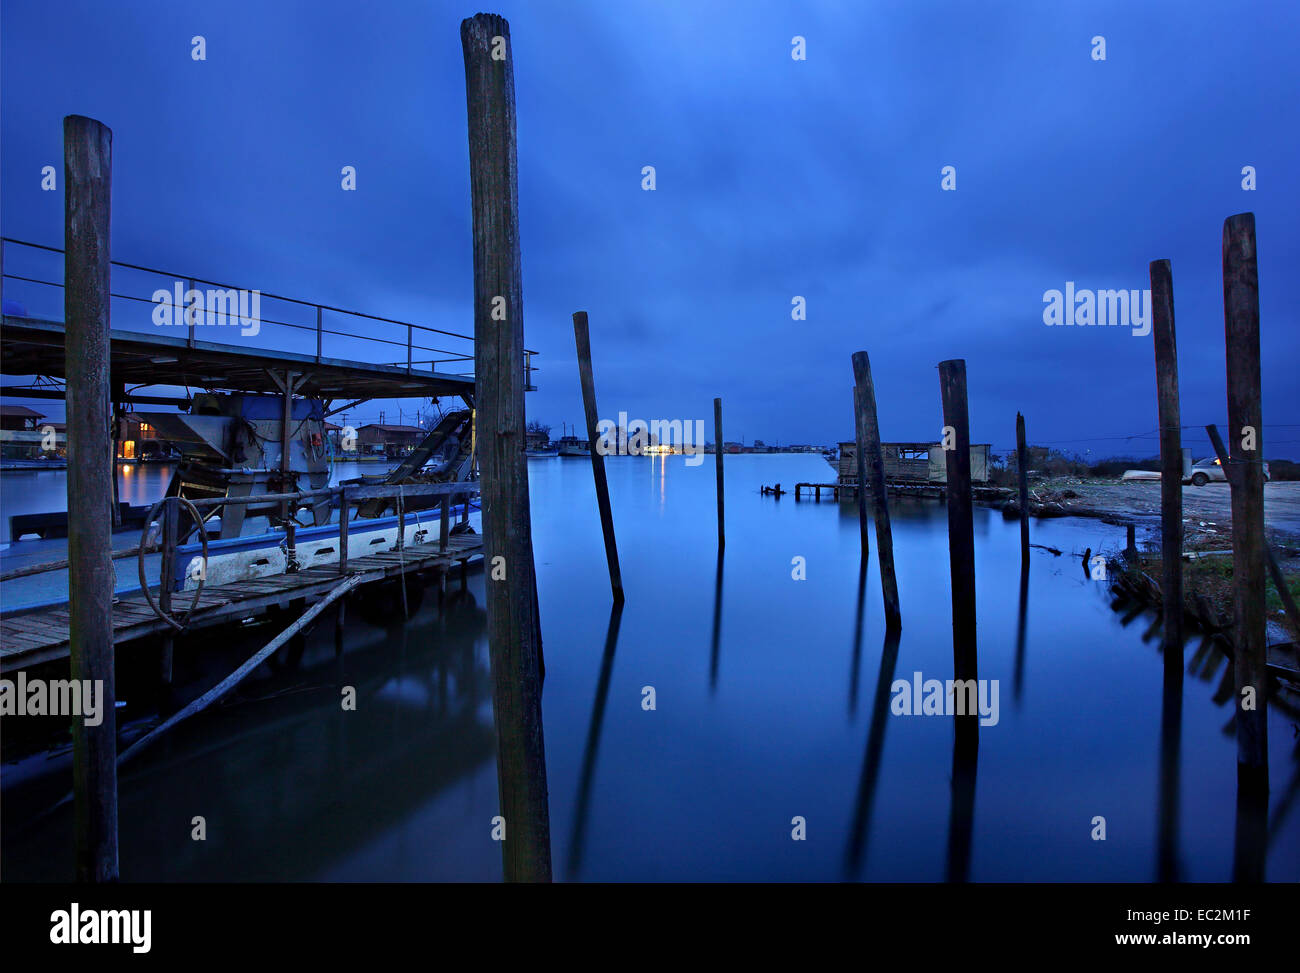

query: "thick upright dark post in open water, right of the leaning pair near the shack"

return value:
[939, 359, 979, 707]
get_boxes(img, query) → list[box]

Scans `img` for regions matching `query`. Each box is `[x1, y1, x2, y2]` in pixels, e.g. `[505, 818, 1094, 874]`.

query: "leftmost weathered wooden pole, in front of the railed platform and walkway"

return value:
[64, 114, 117, 882]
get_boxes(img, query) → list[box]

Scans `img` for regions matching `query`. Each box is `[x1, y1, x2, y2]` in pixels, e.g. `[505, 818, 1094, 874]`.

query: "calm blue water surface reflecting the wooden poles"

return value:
[3, 455, 1300, 882]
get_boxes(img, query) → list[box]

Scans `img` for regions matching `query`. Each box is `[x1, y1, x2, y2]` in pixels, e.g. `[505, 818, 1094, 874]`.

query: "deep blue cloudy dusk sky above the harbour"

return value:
[0, 0, 1300, 458]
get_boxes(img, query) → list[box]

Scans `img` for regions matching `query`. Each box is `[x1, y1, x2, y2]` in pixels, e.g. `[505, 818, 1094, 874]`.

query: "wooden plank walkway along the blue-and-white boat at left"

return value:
[0, 533, 482, 673]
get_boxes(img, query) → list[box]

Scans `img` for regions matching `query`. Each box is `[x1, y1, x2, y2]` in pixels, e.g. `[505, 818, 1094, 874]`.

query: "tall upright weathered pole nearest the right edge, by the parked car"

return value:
[1223, 213, 1269, 793]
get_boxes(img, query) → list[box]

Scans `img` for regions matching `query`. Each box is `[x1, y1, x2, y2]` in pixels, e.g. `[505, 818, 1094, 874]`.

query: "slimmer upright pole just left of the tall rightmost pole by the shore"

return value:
[1151, 260, 1183, 660]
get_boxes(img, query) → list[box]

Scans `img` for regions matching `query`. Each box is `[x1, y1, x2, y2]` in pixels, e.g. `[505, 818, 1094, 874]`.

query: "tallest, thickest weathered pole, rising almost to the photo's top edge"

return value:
[460, 13, 551, 882]
